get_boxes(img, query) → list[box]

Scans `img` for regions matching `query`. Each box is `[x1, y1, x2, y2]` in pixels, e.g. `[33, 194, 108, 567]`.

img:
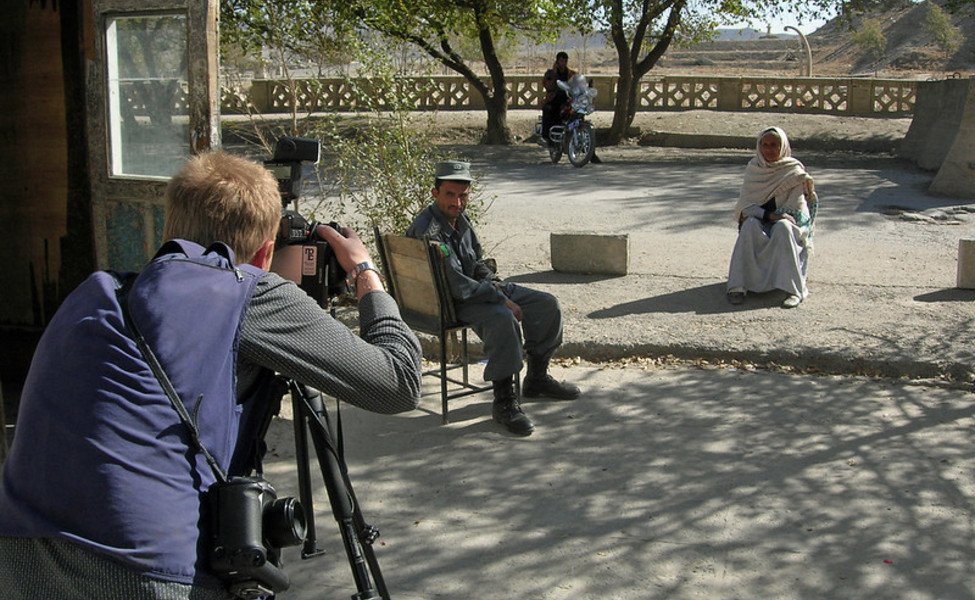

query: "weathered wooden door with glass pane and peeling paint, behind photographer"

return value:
[88, 0, 220, 270]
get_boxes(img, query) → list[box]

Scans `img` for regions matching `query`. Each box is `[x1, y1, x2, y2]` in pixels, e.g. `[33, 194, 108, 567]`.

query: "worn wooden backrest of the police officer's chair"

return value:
[375, 228, 457, 335]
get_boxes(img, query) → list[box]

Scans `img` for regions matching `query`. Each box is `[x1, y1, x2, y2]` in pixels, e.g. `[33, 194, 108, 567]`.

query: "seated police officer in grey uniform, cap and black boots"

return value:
[406, 161, 580, 435]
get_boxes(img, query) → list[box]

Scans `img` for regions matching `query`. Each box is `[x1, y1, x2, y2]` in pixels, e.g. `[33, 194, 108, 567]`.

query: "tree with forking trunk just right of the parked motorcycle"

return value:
[566, 0, 889, 144]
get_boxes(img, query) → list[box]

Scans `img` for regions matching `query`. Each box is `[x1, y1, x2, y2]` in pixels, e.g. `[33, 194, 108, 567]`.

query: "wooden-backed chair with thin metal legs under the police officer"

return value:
[375, 227, 492, 425]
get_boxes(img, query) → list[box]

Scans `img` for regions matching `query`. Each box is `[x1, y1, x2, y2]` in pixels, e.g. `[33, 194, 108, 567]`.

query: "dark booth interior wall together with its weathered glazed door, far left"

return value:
[0, 0, 220, 384]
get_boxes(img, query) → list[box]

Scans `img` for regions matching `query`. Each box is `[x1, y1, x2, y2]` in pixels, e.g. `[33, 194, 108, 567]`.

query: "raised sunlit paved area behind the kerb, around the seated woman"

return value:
[456, 146, 975, 381]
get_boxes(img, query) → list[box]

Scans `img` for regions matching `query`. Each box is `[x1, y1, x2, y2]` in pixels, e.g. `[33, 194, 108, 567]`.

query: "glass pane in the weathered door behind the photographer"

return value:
[106, 15, 190, 178]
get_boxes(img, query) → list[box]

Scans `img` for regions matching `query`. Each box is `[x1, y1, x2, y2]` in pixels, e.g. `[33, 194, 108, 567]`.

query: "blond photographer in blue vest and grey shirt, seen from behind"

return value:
[0, 152, 421, 600]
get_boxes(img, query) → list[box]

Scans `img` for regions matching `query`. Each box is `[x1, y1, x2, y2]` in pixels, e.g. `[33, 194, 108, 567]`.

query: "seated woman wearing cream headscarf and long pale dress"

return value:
[728, 127, 816, 308]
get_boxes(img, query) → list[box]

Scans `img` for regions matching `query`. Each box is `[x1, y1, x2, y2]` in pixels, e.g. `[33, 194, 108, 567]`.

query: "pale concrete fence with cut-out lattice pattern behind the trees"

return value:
[212, 76, 916, 117]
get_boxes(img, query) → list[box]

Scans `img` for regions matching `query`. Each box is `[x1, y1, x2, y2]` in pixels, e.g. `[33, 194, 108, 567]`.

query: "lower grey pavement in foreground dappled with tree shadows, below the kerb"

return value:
[269, 364, 975, 600]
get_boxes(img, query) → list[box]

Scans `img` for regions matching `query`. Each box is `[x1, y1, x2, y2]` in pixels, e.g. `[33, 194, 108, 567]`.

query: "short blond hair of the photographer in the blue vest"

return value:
[164, 151, 281, 264]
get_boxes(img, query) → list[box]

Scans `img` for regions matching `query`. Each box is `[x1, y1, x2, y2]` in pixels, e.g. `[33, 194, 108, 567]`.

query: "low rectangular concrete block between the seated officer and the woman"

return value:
[551, 233, 630, 275]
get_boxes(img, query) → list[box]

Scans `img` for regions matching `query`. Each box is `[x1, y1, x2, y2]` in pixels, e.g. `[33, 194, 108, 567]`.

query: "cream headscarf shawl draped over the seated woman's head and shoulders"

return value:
[735, 127, 811, 222]
